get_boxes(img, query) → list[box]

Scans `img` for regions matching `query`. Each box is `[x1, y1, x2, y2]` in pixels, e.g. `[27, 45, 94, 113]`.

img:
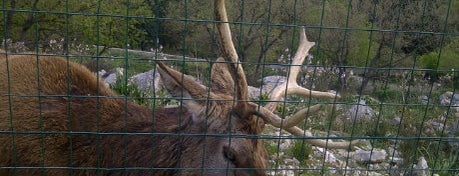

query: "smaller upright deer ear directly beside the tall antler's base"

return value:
[210, 57, 234, 96]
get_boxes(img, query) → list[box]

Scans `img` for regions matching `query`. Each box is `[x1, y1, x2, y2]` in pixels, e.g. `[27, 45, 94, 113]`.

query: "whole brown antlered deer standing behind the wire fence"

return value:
[0, 0, 355, 176]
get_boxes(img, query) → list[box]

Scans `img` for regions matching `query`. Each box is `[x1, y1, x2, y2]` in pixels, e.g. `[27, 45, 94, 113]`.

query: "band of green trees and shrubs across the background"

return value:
[4, 0, 459, 89]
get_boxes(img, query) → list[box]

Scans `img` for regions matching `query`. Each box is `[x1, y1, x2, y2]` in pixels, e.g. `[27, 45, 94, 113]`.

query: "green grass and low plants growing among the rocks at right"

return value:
[258, 70, 459, 175]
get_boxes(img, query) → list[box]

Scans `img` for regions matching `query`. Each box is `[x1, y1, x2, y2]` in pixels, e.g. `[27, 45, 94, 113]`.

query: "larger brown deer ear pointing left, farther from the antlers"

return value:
[157, 62, 210, 120]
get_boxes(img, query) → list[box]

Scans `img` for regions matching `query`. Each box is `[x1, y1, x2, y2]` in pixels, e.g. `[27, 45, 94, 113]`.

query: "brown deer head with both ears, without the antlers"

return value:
[158, 58, 267, 175]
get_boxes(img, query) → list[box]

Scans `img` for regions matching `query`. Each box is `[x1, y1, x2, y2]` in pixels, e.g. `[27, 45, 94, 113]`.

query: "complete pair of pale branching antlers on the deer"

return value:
[216, 0, 357, 149]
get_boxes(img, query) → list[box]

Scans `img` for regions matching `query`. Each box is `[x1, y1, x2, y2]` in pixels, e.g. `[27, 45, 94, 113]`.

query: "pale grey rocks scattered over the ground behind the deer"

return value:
[99, 69, 459, 176]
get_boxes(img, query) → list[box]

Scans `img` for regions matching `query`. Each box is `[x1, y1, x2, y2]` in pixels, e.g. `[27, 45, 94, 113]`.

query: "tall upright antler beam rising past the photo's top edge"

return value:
[216, 0, 252, 115]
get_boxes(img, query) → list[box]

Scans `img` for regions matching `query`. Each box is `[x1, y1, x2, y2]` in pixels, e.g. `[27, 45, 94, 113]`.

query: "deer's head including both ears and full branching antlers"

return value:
[158, 0, 357, 175]
